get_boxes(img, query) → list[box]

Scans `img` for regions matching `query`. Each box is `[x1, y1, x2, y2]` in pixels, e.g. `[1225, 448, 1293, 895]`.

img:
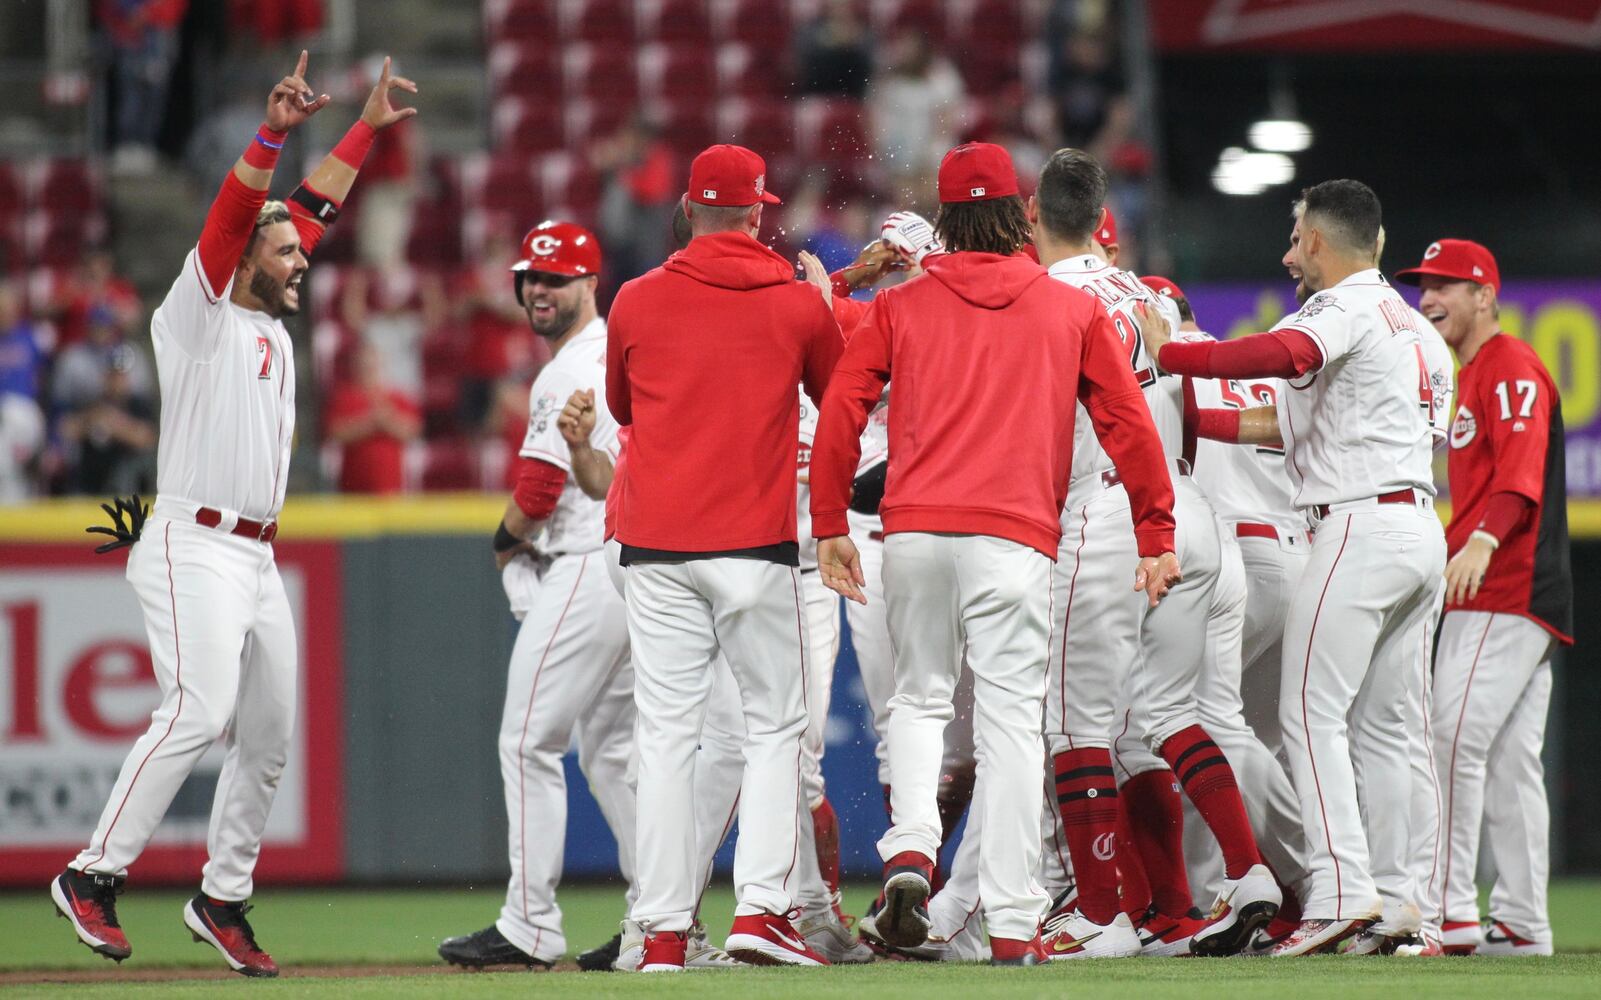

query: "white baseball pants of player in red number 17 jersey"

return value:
[1434, 610, 1556, 942]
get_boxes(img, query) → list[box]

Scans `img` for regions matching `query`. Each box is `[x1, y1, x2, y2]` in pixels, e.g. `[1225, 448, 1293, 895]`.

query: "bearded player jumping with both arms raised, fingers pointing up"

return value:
[50, 51, 416, 976]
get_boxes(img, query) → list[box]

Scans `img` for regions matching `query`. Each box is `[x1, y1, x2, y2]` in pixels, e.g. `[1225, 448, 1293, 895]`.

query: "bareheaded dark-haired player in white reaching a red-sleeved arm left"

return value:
[1146, 181, 1444, 955]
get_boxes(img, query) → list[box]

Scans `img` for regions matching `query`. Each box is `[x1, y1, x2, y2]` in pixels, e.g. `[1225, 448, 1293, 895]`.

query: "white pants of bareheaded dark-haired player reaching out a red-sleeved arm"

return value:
[1279, 499, 1446, 920]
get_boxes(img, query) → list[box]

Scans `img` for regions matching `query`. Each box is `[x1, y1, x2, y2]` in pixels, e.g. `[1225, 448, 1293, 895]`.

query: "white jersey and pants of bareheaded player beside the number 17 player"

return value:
[1278, 269, 1446, 933]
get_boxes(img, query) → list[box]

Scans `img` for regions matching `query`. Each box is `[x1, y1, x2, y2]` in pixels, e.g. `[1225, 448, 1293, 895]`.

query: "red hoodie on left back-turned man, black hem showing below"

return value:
[605, 232, 844, 552]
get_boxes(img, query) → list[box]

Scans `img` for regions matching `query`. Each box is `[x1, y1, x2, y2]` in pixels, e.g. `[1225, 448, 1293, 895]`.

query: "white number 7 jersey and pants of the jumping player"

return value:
[72, 250, 299, 901]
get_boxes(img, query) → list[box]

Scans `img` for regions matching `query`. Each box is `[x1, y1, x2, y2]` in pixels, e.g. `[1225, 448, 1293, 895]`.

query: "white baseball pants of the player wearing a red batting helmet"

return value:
[495, 552, 637, 962]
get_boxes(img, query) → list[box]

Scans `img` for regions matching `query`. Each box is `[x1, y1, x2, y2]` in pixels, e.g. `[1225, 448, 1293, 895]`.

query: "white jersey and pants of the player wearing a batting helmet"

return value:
[495, 318, 637, 962]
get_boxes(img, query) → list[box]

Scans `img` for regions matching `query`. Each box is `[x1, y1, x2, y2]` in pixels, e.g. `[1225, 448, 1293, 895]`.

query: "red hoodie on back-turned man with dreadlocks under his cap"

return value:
[812, 253, 1174, 558]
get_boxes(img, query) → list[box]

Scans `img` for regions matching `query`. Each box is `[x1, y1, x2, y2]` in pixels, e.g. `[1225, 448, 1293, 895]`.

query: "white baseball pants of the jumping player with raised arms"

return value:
[72, 509, 298, 901]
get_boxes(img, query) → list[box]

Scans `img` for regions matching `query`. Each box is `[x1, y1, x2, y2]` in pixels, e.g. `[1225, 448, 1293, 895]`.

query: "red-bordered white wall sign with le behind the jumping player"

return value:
[0, 542, 344, 888]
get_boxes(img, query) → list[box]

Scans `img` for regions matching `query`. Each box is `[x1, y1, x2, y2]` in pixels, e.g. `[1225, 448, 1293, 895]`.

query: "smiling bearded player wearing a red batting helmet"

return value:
[439, 221, 636, 968]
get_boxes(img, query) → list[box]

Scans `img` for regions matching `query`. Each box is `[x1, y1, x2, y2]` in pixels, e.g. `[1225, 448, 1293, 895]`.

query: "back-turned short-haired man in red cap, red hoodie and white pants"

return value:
[607, 146, 842, 971]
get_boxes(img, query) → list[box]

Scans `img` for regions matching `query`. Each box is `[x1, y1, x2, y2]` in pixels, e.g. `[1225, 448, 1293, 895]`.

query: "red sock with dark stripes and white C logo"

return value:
[1053, 747, 1119, 923]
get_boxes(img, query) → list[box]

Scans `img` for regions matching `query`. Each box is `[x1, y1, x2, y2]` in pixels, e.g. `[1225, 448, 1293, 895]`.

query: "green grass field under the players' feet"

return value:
[0, 880, 1601, 1000]
